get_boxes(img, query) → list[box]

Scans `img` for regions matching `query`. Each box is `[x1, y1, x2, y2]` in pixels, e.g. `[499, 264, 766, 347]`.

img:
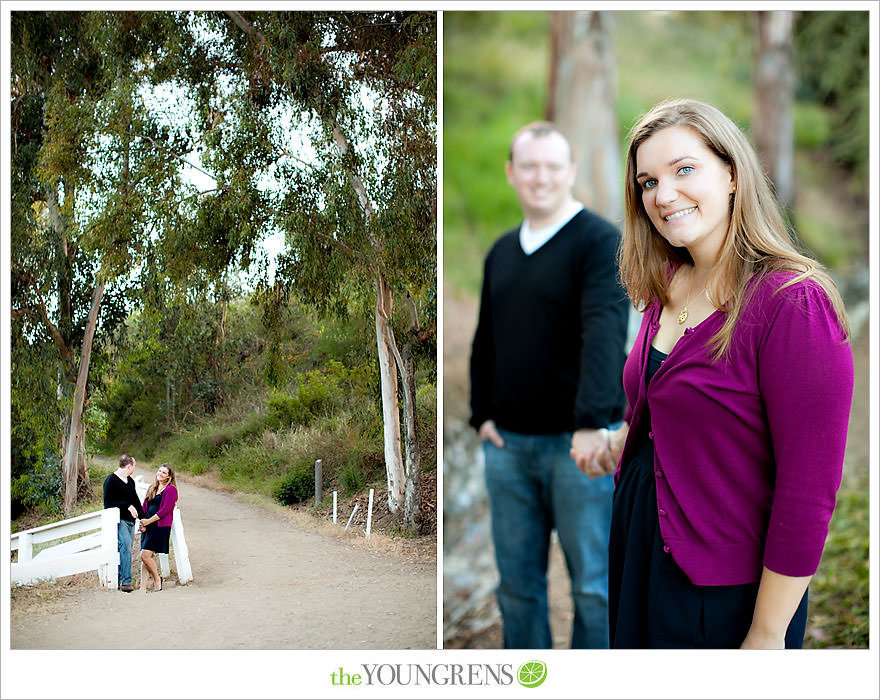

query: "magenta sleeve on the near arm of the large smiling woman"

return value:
[758, 282, 853, 576]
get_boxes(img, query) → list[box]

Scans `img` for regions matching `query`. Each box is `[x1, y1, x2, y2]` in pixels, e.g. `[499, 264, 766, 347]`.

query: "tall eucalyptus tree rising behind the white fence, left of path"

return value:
[10, 11, 191, 513]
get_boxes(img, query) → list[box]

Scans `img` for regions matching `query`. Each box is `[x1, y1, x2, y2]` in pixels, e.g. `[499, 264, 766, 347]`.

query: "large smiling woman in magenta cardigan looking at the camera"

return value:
[581, 95, 853, 648]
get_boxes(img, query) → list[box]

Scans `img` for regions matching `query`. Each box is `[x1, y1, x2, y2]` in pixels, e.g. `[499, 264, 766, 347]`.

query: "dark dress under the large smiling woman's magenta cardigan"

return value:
[608, 346, 807, 649]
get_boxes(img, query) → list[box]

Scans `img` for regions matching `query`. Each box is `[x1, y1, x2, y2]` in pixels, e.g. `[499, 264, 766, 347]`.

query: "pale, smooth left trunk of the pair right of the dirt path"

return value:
[376, 276, 406, 513]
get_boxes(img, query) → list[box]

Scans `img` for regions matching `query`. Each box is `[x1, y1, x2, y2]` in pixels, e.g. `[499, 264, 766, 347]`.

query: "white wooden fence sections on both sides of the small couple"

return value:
[10, 476, 193, 589]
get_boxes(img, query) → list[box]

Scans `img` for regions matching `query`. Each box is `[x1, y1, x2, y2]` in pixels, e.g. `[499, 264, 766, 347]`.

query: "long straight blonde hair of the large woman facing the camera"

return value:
[618, 99, 849, 359]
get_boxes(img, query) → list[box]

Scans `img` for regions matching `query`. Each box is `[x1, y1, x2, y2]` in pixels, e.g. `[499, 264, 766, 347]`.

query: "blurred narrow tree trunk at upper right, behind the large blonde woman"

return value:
[752, 10, 795, 209]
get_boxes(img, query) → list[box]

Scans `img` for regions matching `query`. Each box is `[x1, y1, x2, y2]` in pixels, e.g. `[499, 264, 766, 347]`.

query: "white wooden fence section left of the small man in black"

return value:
[11, 508, 119, 588]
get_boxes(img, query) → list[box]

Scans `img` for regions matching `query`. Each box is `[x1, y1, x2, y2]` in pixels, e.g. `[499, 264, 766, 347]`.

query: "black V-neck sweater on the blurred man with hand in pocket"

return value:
[470, 209, 629, 435]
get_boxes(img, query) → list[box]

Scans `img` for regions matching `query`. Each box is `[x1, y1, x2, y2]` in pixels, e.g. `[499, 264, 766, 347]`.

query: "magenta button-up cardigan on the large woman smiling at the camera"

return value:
[614, 272, 853, 586]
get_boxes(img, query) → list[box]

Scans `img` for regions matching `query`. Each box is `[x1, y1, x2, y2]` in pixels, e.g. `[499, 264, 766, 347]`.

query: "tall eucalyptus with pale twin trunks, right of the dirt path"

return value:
[190, 12, 436, 528]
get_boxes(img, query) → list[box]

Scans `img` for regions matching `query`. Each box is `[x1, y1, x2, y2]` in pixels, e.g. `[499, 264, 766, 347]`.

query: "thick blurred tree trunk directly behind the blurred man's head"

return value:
[547, 10, 623, 223]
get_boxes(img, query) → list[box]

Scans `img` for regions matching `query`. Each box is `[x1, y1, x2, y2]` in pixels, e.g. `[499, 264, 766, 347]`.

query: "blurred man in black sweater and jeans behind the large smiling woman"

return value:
[470, 122, 629, 648]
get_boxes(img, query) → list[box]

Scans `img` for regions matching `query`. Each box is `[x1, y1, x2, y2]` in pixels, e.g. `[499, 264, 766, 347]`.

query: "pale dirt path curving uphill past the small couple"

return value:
[10, 468, 437, 649]
